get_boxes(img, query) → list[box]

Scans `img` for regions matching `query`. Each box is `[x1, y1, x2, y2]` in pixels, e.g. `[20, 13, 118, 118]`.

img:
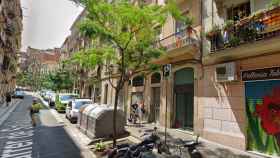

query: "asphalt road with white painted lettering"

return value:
[0, 96, 81, 158]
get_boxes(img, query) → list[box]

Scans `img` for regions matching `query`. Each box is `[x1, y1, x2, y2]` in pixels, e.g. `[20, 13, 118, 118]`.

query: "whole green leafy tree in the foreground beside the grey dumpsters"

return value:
[71, 0, 184, 146]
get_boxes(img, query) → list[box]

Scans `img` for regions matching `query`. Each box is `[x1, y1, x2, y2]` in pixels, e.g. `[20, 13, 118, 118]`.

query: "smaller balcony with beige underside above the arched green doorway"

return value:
[152, 28, 199, 64]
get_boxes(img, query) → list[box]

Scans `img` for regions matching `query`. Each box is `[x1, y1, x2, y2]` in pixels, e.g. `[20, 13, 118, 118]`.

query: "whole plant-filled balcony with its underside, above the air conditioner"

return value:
[204, 7, 280, 64]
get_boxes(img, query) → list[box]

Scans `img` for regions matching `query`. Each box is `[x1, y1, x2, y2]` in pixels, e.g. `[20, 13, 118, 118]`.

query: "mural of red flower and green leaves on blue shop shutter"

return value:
[246, 80, 280, 156]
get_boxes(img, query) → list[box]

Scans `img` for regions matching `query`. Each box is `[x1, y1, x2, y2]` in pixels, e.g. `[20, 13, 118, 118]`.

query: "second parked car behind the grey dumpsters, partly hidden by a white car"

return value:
[55, 93, 78, 112]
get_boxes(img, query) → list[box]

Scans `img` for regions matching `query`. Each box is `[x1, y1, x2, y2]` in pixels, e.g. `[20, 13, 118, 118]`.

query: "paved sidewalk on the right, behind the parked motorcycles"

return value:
[126, 124, 270, 158]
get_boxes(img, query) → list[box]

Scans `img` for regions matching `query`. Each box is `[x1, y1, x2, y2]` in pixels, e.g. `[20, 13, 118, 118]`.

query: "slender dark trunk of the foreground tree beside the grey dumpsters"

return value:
[113, 86, 120, 148]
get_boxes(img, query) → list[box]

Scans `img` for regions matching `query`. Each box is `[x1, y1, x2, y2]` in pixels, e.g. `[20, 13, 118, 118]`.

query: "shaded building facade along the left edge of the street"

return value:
[0, 0, 22, 95]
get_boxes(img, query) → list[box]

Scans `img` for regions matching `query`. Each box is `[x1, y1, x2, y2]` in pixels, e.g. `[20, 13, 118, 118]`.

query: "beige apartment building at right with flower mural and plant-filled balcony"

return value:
[199, 0, 280, 156]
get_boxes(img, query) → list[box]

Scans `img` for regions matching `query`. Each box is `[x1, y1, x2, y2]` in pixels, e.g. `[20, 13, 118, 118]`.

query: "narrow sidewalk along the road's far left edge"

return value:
[0, 99, 21, 126]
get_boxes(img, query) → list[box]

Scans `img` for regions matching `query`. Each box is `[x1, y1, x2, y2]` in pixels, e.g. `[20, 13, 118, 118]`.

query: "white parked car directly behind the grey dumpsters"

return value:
[65, 99, 93, 123]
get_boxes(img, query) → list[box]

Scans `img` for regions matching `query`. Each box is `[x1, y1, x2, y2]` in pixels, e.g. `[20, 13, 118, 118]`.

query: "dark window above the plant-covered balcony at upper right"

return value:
[227, 2, 251, 21]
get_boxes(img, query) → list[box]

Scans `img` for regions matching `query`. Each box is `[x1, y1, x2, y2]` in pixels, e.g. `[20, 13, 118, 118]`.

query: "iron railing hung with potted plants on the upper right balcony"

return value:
[206, 7, 280, 52]
